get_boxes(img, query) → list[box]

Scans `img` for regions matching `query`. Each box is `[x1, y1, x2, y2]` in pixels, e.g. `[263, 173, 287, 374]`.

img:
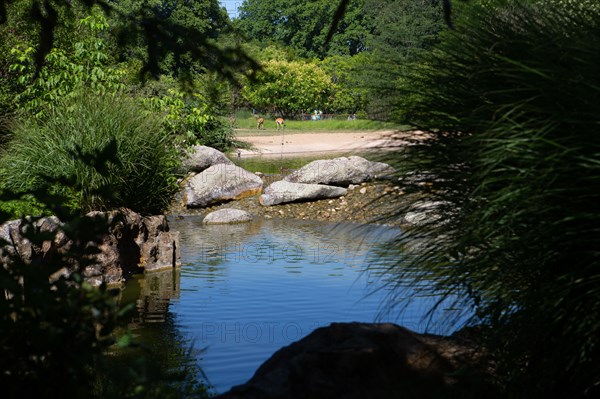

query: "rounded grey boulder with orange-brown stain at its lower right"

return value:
[185, 164, 263, 208]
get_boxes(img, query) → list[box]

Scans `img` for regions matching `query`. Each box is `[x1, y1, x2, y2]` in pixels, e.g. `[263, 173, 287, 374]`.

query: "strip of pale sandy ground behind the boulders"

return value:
[233, 130, 424, 157]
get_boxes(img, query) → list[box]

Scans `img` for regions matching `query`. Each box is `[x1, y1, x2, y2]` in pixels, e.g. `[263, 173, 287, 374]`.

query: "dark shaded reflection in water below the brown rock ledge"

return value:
[105, 268, 208, 398]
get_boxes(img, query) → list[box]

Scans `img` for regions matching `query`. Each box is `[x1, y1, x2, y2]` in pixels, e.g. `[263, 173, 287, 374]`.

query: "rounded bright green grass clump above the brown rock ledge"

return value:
[0, 94, 179, 216]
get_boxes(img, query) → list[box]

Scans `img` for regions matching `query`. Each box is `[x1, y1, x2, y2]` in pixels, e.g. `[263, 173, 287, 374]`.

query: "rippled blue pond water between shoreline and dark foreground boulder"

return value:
[126, 216, 464, 393]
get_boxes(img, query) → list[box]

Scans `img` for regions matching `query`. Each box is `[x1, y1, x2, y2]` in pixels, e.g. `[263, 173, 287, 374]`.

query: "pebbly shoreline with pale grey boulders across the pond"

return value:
[167, 146, 408, 226]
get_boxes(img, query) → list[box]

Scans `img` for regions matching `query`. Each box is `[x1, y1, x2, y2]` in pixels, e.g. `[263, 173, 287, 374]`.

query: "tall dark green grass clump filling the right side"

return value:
[382, 0, 600, 398]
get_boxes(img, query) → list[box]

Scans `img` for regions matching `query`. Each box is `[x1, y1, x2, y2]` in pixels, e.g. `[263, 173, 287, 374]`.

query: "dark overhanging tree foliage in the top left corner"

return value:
[0, 0, 256, 79]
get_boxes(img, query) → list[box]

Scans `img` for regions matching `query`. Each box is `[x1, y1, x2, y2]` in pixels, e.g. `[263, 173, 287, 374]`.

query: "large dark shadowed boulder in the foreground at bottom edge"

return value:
[217, 323, 494, 399]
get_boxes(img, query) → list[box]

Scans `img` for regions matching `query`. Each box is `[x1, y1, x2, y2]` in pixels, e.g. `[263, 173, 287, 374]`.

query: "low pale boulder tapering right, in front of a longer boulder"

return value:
[259, 180, 348, 206]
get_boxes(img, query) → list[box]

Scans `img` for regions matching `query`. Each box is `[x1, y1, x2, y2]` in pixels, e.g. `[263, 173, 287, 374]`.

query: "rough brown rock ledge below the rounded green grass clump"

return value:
[0, 209, 181, 285]
